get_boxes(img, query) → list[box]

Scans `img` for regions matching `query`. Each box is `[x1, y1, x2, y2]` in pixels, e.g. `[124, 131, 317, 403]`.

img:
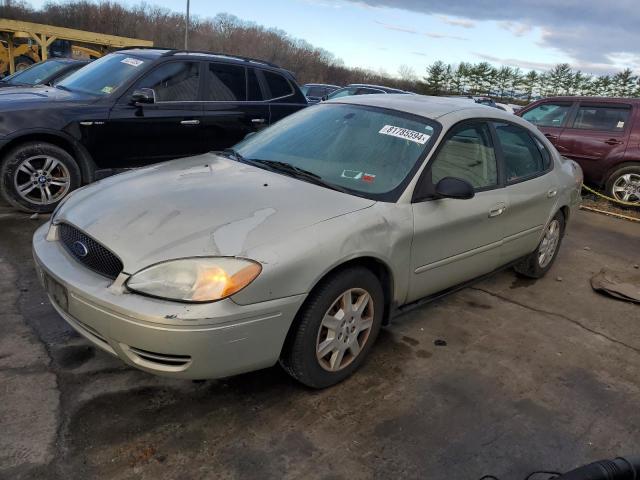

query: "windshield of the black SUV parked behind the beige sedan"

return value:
[57, 53, 149, 96]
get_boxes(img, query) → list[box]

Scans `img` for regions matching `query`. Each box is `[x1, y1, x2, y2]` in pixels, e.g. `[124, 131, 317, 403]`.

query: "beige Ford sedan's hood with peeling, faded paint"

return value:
[55, 153, 375, 273]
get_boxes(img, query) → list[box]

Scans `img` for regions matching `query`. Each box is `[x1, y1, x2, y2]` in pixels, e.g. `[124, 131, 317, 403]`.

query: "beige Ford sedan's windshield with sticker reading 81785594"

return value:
[235, 104, 437, 201]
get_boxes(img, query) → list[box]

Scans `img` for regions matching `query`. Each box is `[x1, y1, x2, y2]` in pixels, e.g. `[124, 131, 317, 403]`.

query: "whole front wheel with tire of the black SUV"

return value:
[0, 142, 82, 213]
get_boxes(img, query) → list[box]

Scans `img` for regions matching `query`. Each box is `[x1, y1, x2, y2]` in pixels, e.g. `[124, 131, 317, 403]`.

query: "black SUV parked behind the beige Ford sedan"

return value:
[0, 49, 307, 212]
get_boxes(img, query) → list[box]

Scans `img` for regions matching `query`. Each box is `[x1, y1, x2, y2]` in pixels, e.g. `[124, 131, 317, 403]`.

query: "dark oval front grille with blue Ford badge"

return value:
[58, 223, 122, 279]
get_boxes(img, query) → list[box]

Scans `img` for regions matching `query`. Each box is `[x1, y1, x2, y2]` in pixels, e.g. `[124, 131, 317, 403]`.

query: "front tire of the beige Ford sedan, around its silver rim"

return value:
[280, 267, 384, 388]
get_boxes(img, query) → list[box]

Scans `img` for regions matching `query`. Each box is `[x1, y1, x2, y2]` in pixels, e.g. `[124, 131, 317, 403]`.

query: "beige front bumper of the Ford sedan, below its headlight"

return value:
[33, 223, 306, 379]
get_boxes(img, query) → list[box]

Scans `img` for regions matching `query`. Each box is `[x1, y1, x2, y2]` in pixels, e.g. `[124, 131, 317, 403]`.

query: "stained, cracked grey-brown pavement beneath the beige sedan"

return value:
[0, 203, 640, 480]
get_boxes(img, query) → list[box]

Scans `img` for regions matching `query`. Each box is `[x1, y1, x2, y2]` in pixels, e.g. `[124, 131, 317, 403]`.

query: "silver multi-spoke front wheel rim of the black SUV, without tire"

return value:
[13, 155, 71, 205]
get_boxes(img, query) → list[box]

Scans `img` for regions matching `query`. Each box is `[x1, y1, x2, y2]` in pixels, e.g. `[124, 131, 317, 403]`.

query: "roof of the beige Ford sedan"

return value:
[325, 94, 531, 128]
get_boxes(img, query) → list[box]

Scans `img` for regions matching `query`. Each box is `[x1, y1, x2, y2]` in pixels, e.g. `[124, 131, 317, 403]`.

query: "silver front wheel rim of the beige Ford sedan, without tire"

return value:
[316, 288, 374, 372]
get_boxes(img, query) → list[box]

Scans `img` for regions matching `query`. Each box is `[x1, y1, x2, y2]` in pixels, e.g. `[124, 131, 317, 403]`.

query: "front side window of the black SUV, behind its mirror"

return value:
[138, 62, 200, 102]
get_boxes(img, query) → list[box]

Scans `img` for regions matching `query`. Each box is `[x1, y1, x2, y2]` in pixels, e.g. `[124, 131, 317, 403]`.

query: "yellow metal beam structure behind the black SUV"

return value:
[0, 18, 153, 73]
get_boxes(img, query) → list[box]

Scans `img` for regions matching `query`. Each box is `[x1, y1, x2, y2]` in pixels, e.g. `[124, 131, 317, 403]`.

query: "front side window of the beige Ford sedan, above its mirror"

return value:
[431, 123, 498, 189]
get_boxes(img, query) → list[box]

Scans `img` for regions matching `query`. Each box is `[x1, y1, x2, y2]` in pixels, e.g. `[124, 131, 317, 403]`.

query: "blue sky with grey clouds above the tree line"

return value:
[31, 0, 640, 75]
